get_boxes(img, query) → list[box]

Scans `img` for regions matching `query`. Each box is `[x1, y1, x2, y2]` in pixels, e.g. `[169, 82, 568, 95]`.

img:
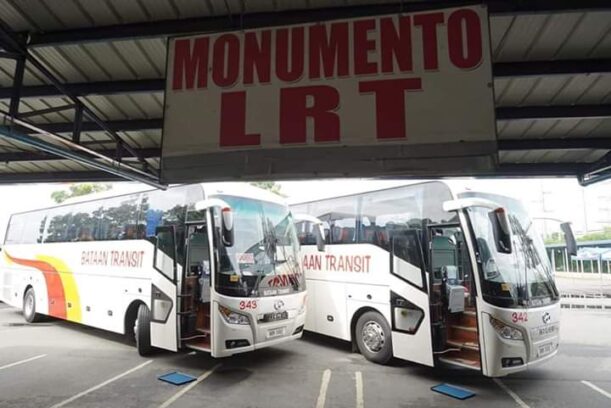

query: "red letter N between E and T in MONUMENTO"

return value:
[380, 16, 412, 73]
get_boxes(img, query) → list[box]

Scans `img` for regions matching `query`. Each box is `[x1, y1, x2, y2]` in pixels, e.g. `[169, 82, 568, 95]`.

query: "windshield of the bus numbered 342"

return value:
[459, 192, 559, 307]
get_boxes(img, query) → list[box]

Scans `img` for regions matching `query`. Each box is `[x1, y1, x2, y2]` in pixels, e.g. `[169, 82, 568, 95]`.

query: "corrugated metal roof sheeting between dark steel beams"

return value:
[0, 0, 611, 180]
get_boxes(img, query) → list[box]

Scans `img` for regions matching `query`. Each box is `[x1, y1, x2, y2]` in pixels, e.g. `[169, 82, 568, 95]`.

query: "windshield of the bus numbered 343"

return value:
[216, 196, 305, 297]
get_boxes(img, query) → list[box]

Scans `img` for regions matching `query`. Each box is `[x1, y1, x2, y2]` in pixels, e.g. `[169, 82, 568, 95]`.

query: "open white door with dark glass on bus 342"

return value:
[390, 230, 433, 366]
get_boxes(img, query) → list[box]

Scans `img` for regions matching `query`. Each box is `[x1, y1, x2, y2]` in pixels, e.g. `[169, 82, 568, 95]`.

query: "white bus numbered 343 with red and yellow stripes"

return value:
[0, 183, 306, 357]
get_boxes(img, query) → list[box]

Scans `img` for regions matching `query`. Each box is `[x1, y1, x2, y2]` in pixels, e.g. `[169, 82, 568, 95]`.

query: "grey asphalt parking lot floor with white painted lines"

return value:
[0, 304, 611, 408]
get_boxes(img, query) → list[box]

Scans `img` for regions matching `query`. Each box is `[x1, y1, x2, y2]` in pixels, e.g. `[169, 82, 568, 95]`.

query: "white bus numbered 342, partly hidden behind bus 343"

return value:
[292, 181, 574, 377]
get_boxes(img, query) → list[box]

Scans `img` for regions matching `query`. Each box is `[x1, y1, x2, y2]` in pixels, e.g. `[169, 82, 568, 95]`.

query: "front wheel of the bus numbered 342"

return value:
[355, 312, 392, 364]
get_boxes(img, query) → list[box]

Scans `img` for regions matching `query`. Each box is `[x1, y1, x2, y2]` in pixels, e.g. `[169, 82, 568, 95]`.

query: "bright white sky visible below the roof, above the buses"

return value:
[0, 178, 611, 242]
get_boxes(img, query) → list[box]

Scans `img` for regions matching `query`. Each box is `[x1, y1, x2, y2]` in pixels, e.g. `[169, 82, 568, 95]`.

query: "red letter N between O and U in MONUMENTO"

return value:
[243, 30, 272, 84]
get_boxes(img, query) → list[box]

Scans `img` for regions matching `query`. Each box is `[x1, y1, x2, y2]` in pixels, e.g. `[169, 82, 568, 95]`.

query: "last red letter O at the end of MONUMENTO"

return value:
[448, 9, 482, 69]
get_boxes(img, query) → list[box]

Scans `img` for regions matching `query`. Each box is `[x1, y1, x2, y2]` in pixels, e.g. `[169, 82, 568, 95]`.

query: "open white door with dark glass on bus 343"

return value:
[151, 226, 178, 351]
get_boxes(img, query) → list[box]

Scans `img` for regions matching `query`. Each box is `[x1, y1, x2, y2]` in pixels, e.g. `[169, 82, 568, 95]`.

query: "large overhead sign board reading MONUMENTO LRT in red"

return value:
[162, 5, 496, 182]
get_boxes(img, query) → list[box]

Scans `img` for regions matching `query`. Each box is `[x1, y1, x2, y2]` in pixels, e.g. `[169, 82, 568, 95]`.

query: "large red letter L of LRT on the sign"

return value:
[219, 91, 261, 147]
